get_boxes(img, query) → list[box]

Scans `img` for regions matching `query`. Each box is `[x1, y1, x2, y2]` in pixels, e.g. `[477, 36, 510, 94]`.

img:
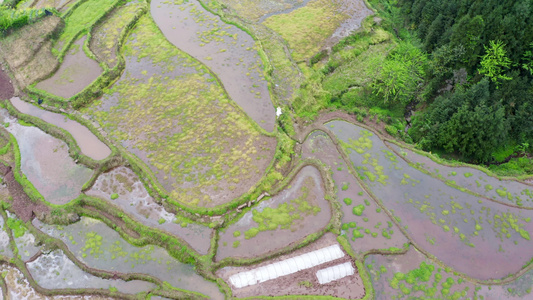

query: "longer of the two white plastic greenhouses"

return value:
[229, 244, 342, 288]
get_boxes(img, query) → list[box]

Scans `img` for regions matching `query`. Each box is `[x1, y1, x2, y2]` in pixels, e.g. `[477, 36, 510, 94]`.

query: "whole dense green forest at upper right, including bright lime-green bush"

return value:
[320, 0, 533, 175]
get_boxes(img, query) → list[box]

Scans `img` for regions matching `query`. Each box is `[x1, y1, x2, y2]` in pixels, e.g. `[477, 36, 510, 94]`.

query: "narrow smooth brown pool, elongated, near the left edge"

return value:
[11, 97, 111, 160]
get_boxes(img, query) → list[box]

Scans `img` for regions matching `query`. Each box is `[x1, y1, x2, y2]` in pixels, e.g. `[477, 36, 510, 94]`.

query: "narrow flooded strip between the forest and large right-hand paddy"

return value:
[387, 143, 533, 207]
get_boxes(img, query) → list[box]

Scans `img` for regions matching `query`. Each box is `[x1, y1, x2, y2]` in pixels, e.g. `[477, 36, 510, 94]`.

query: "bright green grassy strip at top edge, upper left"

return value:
[54, 0, 118, 54]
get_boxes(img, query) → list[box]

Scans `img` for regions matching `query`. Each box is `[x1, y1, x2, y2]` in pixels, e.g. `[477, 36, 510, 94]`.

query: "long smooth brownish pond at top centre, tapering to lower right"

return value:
[150, 0, 276, 132]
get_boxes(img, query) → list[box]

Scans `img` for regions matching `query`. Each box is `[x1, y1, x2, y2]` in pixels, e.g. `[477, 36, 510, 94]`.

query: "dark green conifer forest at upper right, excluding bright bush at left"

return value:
[384, 0, 533, 162]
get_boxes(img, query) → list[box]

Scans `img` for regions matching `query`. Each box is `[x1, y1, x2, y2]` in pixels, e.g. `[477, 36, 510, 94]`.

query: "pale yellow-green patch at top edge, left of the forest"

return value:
[263, 0, 349, 61]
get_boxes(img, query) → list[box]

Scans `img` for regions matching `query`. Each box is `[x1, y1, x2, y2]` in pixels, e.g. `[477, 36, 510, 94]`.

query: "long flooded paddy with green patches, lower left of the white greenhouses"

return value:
[33, 217, 224, 299]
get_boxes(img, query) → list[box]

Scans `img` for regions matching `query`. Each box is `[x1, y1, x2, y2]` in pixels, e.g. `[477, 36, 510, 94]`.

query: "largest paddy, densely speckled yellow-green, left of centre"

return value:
[86, 17, 275, 206]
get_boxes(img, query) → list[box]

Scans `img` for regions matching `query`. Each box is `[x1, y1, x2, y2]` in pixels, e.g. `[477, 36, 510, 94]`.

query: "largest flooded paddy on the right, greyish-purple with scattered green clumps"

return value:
[326, 121, 533, 280]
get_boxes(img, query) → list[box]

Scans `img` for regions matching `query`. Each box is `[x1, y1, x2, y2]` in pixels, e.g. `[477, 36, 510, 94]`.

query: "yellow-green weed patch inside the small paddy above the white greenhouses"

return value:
[244, 177, 321, 239]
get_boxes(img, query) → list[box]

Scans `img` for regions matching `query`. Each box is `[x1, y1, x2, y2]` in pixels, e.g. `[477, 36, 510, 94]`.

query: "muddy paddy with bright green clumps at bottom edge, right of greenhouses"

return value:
[365, 247, 475, 300]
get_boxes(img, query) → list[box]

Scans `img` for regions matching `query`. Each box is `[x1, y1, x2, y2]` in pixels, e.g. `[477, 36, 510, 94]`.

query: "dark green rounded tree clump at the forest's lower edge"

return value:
[411, 79, 509, 162]
